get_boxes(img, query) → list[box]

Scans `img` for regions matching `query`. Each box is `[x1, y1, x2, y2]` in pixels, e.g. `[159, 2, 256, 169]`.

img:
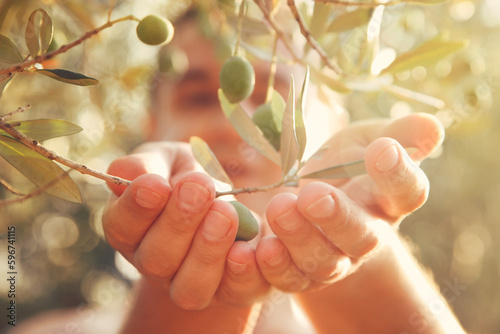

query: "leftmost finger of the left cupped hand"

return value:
[102, 174, 171, 260]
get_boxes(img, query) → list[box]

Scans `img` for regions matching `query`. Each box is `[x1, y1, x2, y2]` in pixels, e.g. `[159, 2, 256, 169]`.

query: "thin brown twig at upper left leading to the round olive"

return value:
[0, 15, 140, 78]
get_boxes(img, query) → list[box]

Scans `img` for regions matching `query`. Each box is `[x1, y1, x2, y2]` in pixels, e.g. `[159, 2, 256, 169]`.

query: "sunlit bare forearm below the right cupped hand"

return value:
[297, 233, 464, 334]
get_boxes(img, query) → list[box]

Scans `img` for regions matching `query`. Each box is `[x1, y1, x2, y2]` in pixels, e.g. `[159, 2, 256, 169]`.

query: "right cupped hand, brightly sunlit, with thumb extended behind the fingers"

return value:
[256, 114, 443, 292]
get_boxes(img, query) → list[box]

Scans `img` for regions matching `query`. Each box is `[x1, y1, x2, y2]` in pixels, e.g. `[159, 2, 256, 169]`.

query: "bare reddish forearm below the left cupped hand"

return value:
[120, 279, 252, 334]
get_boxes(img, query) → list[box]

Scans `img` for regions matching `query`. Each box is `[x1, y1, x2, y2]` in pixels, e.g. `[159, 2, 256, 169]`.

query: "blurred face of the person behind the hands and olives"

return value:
[150, 18, 289, 211]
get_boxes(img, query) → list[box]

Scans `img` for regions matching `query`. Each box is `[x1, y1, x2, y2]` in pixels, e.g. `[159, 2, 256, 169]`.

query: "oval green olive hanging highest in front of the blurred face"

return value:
[219, 56, 255, 103]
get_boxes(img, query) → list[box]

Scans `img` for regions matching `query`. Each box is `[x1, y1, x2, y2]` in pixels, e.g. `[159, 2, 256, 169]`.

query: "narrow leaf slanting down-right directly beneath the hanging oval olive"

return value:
[218, 89, 280, 165]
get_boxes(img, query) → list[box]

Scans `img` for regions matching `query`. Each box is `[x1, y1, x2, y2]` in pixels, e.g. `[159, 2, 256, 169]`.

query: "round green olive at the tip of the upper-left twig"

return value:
[136, 15, 174, 45]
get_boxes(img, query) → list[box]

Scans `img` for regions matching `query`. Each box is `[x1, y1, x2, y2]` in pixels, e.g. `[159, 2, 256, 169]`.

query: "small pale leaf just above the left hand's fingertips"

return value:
[189, 136, 234, 188]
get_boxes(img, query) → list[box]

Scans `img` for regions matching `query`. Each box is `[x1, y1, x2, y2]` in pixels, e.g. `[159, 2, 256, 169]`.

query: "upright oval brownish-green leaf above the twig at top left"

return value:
[25, 8, 54, 58]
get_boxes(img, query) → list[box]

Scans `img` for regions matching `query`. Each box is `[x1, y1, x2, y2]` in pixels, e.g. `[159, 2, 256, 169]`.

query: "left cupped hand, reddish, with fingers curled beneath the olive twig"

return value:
[103, 143, 269, 310]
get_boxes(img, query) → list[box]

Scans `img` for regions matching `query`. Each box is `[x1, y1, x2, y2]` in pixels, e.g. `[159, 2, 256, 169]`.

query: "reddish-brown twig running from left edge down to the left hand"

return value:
[0, 106, 131, 186]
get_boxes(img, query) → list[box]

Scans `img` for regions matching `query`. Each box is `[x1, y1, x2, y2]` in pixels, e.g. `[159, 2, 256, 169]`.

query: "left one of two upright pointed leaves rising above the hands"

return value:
[281, 75, 299, 177]
